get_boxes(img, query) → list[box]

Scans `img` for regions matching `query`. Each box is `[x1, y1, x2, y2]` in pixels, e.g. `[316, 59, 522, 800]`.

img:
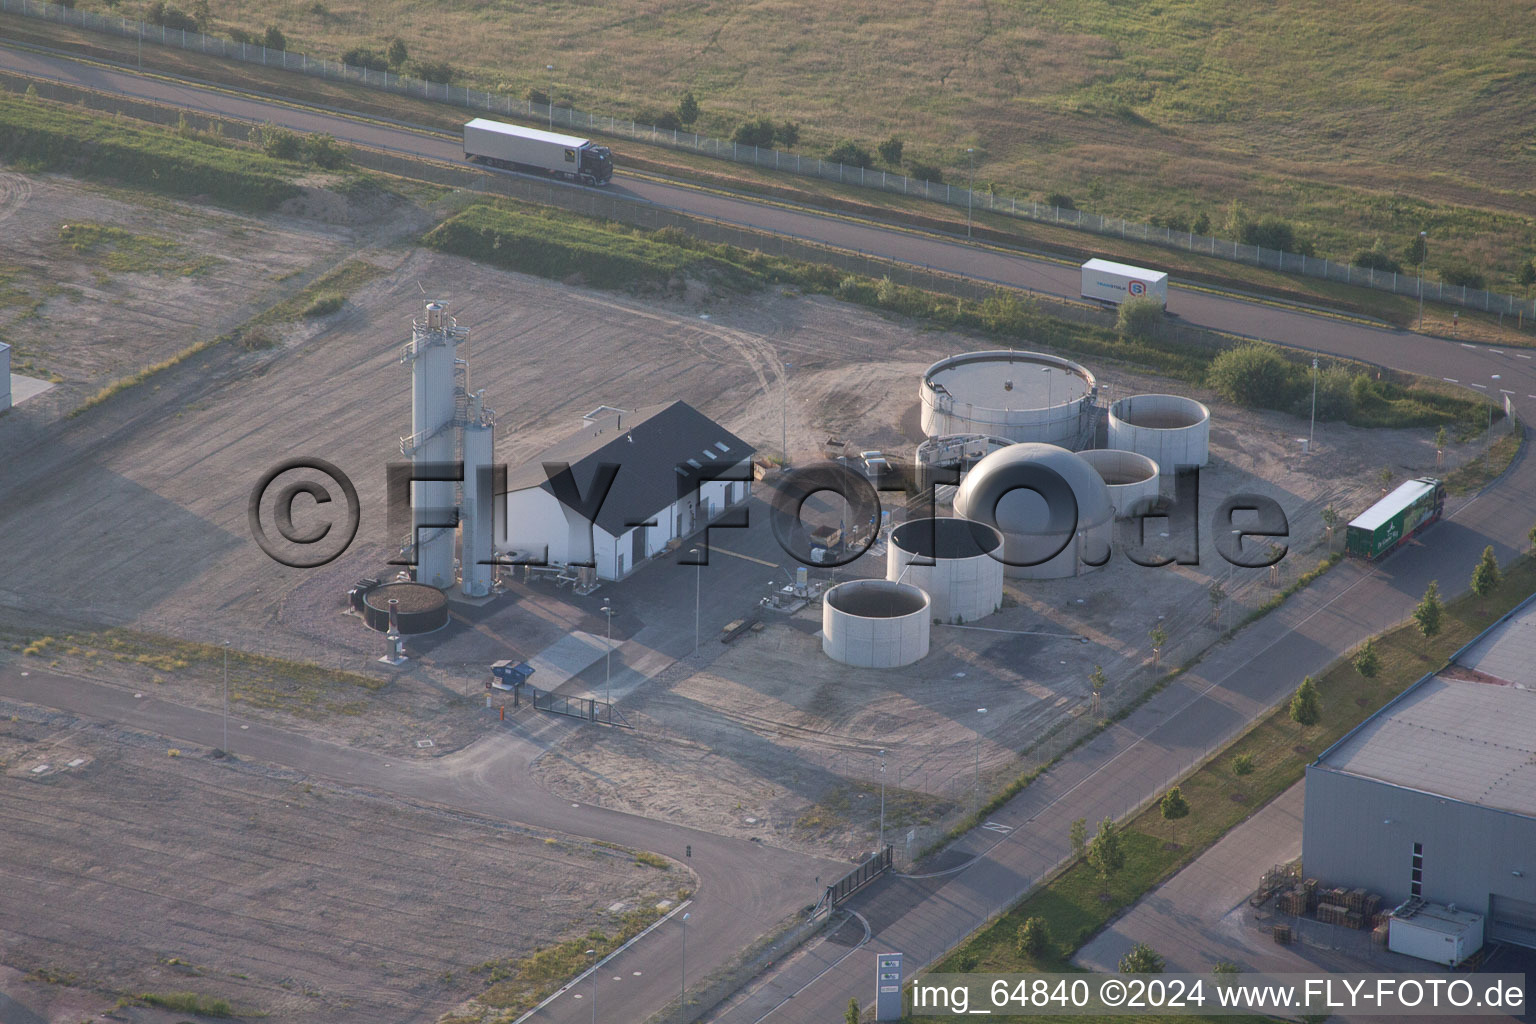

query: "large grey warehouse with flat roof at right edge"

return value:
[1301, 602, 1536, 949]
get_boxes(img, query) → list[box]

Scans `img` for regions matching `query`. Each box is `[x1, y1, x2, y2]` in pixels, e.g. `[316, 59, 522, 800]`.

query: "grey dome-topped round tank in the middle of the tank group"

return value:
[954, 444, 1115, 579]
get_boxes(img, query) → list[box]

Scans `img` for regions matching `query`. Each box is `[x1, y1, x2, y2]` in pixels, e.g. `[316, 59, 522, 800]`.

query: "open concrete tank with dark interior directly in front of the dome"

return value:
[885, 519, 1003, 622]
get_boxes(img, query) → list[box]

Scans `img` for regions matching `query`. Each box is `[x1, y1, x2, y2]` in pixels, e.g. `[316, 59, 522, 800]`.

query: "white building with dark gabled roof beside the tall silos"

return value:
[496, 402, 756, 580]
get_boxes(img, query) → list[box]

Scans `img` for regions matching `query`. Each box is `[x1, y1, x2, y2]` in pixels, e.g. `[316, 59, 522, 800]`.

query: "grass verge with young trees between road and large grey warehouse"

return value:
[935, 556, 1536, 973]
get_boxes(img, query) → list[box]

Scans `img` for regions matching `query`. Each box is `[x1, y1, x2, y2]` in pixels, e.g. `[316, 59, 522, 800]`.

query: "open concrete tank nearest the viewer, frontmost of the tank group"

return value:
[822, 580, 932, 668]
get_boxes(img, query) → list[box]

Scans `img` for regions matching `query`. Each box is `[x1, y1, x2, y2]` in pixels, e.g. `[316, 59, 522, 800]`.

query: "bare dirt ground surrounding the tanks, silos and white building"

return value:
[0, 166, 1476, 852]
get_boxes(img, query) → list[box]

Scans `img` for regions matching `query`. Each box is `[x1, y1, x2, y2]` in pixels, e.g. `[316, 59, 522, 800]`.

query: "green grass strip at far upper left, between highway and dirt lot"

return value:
[0, 94, 300, 210]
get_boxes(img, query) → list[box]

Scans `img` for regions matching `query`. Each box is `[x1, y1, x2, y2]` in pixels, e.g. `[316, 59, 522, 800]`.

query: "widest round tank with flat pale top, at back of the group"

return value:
[919, 352, 1098, 448]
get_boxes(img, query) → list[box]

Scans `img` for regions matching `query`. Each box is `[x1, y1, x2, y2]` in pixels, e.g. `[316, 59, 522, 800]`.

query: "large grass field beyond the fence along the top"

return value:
[80, 0, 1536, 287]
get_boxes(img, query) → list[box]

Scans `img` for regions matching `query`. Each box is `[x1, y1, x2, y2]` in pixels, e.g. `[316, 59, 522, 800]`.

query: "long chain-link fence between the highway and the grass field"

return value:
[12, 0, 1536, 318]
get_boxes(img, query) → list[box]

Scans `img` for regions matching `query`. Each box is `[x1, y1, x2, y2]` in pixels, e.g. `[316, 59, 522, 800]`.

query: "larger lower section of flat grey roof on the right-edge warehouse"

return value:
[1318, 675, 1536, 817]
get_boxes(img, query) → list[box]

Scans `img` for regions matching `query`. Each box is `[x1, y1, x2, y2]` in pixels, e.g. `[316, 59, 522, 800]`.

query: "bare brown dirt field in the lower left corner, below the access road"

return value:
[0, 705, 679, 1024]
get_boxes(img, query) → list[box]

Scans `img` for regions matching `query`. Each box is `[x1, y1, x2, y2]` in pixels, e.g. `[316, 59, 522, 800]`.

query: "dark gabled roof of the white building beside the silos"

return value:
[507, 402, 756, 536]
